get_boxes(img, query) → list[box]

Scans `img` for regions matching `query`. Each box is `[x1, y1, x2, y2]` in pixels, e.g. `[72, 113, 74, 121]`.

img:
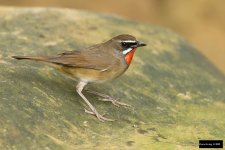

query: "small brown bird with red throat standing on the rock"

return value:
[12, 34, 146, 121]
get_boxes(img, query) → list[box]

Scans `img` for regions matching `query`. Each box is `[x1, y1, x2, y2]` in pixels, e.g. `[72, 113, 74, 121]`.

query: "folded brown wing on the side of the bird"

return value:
[48, 44, 113, 70]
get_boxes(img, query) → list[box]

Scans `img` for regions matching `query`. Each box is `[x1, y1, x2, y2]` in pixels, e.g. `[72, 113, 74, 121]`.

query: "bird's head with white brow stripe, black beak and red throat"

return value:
[110, 34, 146, 65]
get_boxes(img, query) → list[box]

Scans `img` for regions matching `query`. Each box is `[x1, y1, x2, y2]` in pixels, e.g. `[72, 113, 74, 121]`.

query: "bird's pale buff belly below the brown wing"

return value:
[59, 67, 126, 82]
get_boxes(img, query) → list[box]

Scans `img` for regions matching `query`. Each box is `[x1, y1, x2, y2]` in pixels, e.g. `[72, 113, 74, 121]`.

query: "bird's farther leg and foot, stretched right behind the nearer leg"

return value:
[85, 89, 131, 107]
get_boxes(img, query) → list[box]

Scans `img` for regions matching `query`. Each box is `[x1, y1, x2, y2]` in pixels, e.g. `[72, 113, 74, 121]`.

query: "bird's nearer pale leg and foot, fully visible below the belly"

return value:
[76, 81, 114, 121]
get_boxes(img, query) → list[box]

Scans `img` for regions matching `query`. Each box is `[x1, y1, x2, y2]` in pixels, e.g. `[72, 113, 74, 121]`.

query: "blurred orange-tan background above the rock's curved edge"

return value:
[0, 0, 225, 73]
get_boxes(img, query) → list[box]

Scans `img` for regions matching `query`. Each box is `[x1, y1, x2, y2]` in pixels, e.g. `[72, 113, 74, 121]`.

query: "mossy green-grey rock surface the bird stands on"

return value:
[0, 7, 225, 150]
